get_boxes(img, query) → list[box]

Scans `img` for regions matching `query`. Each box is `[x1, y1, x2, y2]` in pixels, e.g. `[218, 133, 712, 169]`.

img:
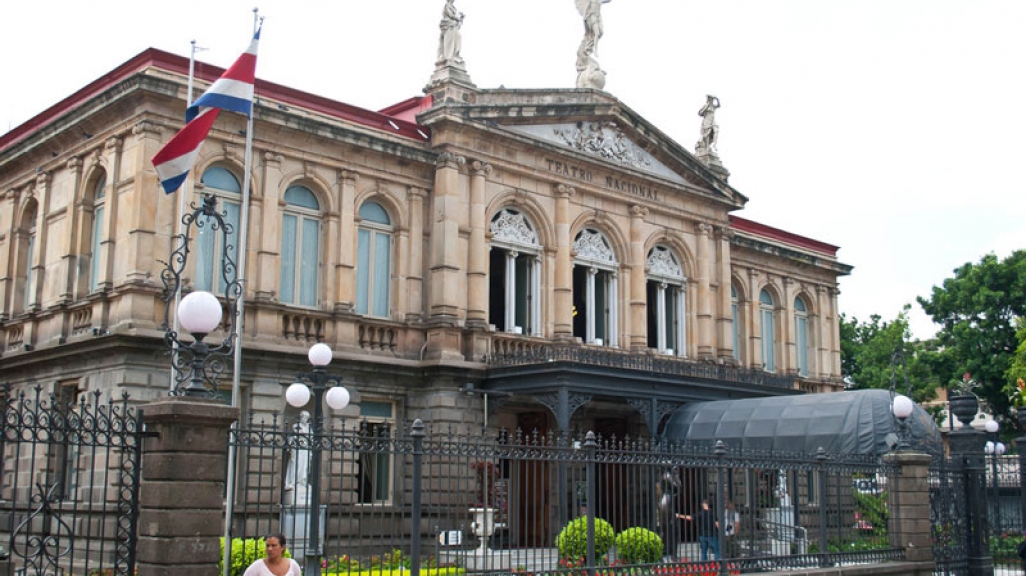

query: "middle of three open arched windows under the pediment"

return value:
[574, 228, 619, 347]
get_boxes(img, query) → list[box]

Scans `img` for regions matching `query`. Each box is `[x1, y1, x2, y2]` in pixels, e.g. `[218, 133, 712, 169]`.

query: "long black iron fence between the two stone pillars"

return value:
[230, 420, 904, 574]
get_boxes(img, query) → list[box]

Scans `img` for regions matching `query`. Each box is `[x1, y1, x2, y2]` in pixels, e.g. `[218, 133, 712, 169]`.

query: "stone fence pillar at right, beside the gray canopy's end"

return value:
[883, 451, 934, 574]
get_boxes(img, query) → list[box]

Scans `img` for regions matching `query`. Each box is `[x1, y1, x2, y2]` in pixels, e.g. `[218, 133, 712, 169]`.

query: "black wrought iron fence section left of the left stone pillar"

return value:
[0, 385, 142, 576]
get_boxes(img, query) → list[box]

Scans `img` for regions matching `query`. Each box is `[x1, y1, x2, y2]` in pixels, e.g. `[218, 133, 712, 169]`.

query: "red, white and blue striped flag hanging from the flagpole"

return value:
[153, 30, 260, 194]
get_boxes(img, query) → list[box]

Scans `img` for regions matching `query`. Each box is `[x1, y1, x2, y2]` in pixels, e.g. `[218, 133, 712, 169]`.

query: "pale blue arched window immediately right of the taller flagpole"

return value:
[280, 186, 320, 306]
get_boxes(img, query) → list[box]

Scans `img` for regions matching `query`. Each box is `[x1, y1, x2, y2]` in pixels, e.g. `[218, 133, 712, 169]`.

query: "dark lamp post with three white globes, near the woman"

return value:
[285, 343, 349, 576]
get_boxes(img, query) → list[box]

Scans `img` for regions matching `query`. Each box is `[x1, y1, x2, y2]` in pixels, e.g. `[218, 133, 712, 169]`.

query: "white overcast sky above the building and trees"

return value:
[0, 0, 1026, 337]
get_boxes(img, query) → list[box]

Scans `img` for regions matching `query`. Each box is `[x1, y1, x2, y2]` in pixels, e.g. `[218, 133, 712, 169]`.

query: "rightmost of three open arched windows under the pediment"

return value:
[645, 245, 687, 356]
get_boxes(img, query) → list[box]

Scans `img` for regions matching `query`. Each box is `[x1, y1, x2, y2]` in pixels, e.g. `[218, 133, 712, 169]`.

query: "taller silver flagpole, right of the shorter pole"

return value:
[222, 8, 263, 576]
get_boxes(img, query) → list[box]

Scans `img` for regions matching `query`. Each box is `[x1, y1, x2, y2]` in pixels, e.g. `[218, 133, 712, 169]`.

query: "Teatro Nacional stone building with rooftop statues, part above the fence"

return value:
[0, 4, 852, 435]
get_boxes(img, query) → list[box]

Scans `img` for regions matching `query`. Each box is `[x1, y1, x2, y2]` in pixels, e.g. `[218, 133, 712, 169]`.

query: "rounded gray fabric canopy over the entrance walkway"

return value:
[663, 390, 944, 456]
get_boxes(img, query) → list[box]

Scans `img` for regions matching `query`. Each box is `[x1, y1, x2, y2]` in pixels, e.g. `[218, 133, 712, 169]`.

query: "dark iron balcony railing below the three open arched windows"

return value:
[487, 337, 795, 390]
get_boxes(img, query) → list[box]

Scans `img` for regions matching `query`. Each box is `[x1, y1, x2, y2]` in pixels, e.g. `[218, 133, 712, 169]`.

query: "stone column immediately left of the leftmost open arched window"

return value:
[467, 161, 492, 331]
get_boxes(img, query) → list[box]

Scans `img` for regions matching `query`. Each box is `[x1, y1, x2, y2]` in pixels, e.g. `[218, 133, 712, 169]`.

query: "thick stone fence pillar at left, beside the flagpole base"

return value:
[136, 396, 239, 576]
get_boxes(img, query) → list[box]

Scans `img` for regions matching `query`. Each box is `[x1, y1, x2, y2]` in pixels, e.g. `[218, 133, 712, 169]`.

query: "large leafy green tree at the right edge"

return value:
[916, 251, 1026, 415]
